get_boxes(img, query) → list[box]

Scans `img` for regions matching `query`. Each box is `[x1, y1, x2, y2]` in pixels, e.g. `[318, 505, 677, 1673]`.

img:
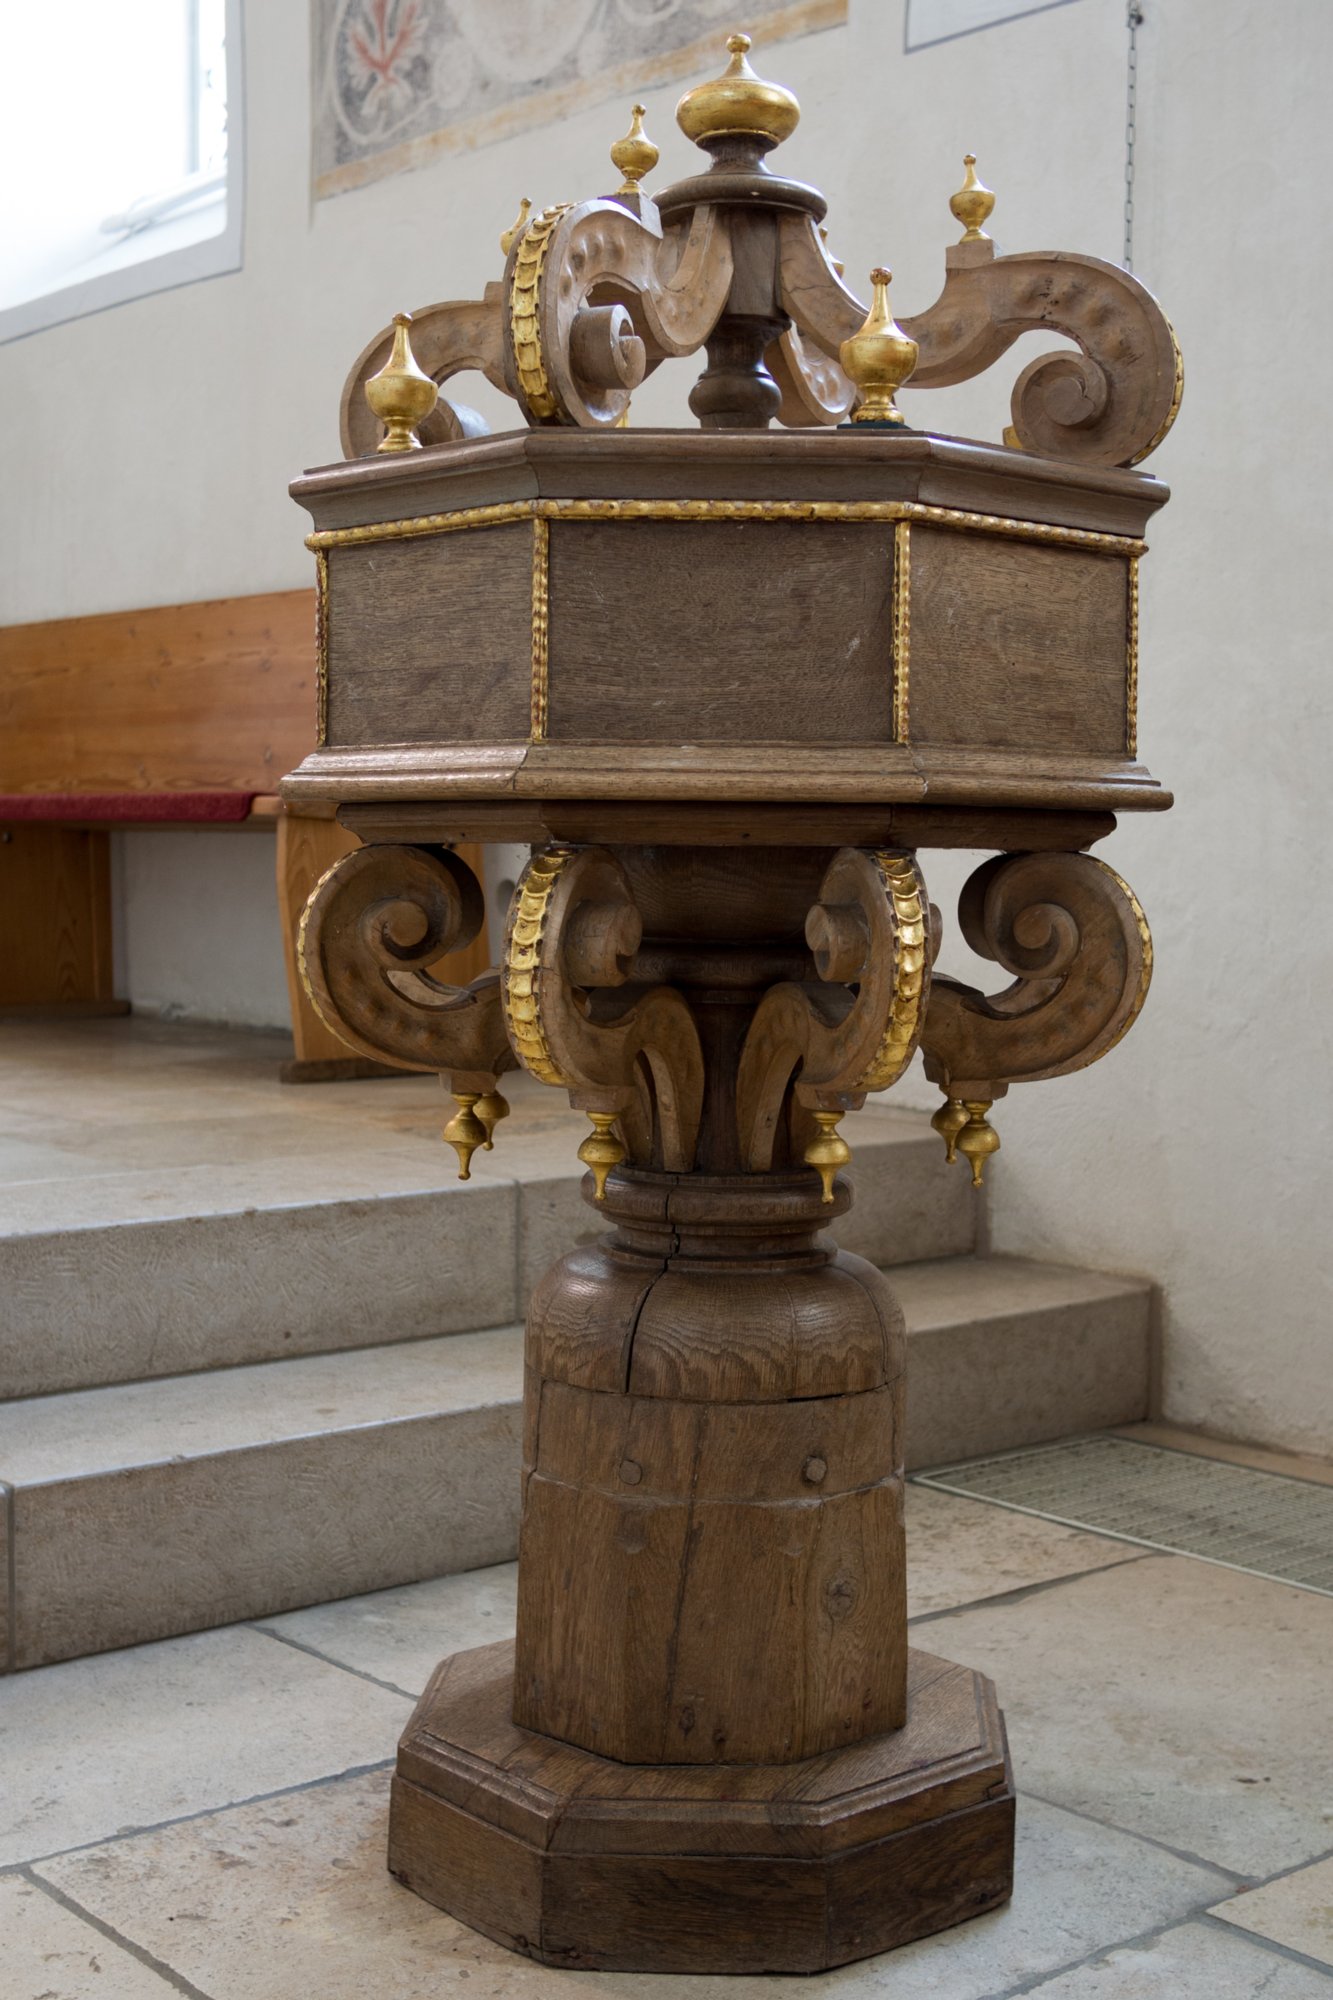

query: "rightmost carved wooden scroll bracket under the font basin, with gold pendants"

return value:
[921, 854, 1153, 1180]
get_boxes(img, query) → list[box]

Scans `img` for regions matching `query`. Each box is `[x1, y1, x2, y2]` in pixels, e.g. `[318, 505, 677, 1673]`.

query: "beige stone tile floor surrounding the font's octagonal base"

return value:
[0, 1456, 1333, 2000]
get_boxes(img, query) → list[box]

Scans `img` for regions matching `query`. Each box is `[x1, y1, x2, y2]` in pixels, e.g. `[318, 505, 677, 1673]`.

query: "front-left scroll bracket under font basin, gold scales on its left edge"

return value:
[502, 848, 705, 1198]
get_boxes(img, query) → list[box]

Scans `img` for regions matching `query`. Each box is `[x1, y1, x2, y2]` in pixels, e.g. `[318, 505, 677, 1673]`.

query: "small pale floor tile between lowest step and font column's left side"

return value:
[260, 1562, 518, 1694]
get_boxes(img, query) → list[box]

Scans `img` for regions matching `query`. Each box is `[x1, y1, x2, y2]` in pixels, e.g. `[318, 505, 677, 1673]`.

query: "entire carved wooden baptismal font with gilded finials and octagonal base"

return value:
[286, 36, 1181, 1972]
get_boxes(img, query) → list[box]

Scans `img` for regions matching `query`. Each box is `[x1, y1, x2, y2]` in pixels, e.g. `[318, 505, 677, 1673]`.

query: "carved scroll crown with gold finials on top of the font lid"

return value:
[340, 36, 1183, 466]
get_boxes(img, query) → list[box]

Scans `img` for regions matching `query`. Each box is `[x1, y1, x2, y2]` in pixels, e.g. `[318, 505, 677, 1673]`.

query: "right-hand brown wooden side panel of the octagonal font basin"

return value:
[911, 526, 1129, 756]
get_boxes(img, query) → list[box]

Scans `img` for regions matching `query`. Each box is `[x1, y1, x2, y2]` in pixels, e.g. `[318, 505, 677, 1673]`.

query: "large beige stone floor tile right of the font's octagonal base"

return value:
[912, 1556, 1333, 1880]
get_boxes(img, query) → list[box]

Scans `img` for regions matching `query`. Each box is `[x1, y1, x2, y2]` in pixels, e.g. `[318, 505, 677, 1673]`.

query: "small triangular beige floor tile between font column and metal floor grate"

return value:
[907, 1486, 1137, 1616]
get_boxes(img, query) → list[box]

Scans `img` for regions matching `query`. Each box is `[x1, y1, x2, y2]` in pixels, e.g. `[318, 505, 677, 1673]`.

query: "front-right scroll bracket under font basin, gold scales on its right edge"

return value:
[737, 848, 931, 1202]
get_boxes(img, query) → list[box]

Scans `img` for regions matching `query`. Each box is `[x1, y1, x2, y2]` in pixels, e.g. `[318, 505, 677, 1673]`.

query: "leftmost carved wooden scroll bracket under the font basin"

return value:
[298, 846, 516, 1090]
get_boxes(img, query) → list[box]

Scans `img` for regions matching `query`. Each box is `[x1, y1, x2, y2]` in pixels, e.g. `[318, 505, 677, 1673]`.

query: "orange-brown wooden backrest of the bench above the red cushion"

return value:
[0, 590, 316, 794]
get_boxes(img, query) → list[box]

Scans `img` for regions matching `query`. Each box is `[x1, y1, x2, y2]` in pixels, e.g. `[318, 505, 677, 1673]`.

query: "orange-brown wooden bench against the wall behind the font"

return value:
[0, 590, 488, 1082]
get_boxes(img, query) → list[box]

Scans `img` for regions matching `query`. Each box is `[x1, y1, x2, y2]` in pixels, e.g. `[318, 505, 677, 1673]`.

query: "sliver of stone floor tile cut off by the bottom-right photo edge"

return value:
[1025, 1924, 1333, 2000]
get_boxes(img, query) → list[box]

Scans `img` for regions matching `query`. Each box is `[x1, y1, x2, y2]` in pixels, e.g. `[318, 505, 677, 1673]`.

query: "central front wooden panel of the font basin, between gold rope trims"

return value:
[548, 520, 893, 744]
